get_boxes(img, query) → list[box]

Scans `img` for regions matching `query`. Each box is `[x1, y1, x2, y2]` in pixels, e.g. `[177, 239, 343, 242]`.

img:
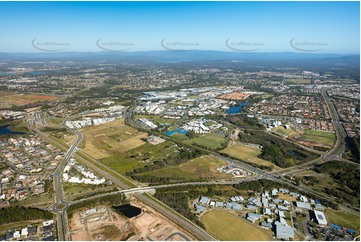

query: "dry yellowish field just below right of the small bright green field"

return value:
[221, 143, 273, 166]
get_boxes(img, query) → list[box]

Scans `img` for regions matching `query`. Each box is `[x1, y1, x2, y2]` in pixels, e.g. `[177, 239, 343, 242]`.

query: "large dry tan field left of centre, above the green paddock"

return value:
[80, 119, 148, 159]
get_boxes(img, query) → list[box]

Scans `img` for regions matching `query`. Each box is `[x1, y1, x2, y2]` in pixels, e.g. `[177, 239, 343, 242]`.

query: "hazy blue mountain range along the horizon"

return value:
[0, 50, 360, 62]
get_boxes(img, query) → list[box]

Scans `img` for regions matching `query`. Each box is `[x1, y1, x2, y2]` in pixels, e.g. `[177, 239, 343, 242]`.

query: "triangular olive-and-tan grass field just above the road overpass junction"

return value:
[138, 155, 231, 179]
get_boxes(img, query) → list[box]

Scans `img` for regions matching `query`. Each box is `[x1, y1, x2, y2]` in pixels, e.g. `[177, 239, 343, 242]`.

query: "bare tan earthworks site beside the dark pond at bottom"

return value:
[69, 199, 194, 241]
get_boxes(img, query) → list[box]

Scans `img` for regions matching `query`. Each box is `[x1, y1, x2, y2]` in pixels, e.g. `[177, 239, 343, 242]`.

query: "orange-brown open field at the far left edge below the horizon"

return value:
[0, 91, 58, 108]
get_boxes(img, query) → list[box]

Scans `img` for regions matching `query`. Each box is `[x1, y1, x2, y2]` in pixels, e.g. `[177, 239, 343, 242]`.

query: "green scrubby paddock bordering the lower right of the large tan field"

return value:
[100, 141, 177, 173]
